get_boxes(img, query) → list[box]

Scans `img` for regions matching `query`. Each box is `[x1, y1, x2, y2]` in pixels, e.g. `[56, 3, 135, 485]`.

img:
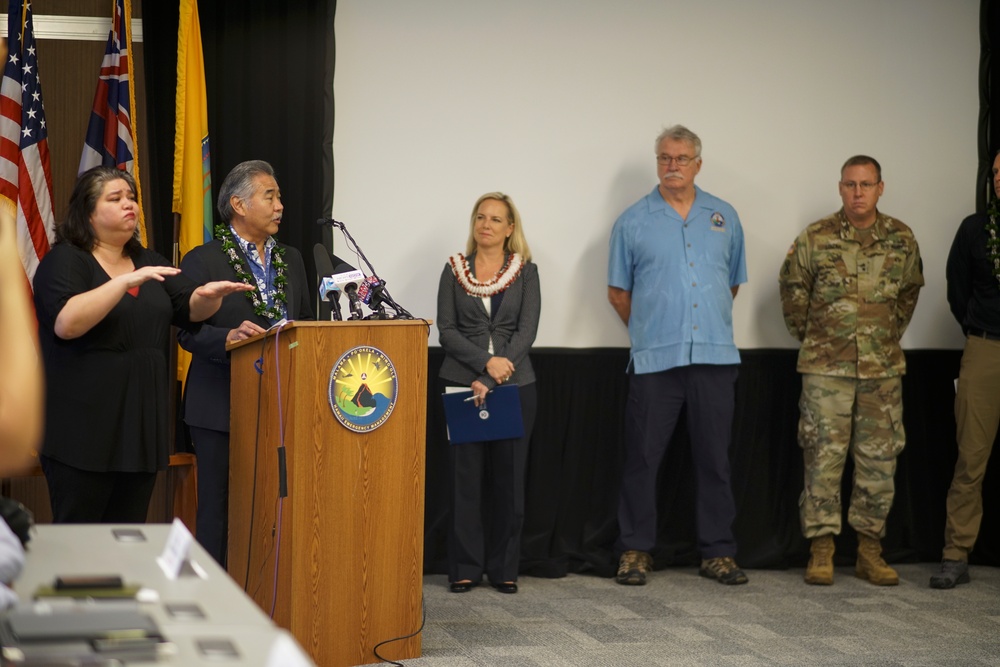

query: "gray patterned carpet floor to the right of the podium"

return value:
[386, 563, 1000, 667]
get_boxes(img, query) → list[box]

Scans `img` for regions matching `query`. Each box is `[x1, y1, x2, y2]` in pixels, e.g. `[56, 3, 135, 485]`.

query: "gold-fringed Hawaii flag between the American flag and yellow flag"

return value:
[78, 0, 146, 245]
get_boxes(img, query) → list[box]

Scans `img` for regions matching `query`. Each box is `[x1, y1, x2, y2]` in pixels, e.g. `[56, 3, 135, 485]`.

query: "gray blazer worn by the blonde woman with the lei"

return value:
[437, 253, 542, 389]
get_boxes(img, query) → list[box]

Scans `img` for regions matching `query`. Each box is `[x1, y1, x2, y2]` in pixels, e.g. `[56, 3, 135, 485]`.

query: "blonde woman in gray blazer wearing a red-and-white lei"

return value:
[437, 192, 541, 593]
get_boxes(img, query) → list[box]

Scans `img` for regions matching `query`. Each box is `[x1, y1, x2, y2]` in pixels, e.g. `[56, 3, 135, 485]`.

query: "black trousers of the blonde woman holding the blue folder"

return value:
[440, 381, 537, 583]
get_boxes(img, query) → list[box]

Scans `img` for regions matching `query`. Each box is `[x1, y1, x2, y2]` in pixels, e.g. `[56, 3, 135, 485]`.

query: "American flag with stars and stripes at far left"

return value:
[0, 0, 55, 288]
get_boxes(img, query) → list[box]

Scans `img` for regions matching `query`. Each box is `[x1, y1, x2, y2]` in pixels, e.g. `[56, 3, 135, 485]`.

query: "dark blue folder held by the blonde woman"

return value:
[441, 384, 524, 445]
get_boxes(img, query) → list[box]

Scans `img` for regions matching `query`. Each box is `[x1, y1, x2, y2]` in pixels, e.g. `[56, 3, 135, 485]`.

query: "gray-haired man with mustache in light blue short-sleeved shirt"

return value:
[608, 125, 747, 585]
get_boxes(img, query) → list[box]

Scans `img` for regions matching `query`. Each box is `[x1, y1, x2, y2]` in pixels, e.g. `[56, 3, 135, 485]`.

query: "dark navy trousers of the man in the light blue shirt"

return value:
[616, 364, 738, 559]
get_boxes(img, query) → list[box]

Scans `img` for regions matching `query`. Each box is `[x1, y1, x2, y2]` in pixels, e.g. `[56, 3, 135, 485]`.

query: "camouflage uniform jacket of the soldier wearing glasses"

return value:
[778, 209, 924, 379]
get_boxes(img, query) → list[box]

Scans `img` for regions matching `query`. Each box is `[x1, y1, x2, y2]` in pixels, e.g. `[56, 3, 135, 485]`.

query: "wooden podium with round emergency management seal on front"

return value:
[228, 320, 428, 667]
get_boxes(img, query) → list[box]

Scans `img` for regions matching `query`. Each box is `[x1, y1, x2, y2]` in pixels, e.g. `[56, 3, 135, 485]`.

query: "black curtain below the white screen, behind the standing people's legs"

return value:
[424, 348, 1000, 577]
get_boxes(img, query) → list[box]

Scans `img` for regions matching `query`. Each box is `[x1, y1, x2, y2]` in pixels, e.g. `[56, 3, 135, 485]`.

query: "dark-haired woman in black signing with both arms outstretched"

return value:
[34, 167, 252, 523]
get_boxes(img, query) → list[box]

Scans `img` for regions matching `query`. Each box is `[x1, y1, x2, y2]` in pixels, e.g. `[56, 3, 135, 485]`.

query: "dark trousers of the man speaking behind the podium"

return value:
[190, 426, 229, 568]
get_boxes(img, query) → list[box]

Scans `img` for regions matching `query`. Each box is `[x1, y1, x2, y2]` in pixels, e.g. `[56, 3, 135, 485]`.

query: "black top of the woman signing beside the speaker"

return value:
[34, 243, 197, 472]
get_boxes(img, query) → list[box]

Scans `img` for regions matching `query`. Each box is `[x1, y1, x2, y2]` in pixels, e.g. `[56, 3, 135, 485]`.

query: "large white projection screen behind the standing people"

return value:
[333, 0, 979, 349]
